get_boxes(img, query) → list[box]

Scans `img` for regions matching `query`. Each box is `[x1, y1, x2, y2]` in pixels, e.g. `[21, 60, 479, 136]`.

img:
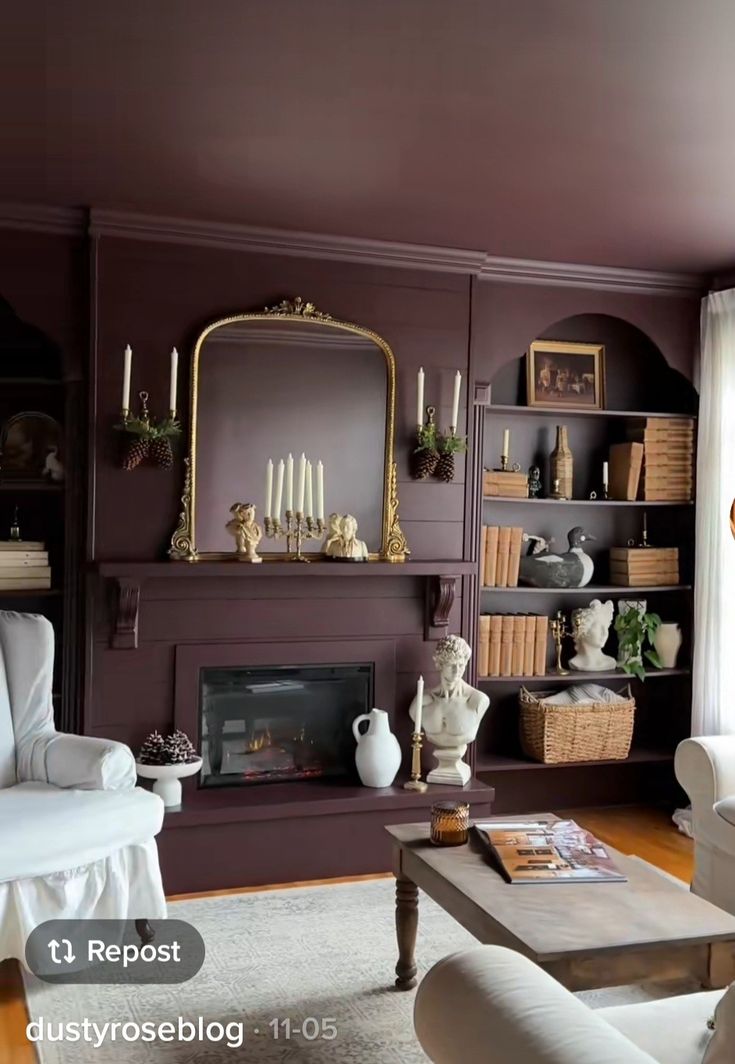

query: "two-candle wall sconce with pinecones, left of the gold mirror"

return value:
[115, 345, 181, 470]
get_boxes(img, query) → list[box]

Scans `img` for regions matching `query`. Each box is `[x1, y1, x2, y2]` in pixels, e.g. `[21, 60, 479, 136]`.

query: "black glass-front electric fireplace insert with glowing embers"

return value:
[199, 664, 374, 787]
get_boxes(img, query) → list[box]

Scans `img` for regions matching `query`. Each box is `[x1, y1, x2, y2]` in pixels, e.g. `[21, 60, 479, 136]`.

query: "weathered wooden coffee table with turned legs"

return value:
[386, 813, 735, 991]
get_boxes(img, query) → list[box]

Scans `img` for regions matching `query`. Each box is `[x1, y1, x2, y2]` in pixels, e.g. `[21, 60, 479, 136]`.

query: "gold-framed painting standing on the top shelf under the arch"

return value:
[525, 339, 605, 410]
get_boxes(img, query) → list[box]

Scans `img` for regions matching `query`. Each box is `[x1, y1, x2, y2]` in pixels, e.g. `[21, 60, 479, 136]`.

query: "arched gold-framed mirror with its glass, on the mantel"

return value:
[169, 298, 408, 562]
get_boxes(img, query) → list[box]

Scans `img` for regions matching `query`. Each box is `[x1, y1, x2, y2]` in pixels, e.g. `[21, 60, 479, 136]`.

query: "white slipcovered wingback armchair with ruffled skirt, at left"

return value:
[0, 611, 166, 962]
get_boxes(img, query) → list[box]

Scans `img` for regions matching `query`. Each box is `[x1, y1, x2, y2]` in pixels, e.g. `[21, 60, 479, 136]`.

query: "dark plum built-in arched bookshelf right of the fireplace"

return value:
[474, 316, 697, 811]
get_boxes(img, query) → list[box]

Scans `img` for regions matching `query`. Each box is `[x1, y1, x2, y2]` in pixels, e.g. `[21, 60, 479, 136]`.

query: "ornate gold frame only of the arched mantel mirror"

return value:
[168, 296, 411, 562]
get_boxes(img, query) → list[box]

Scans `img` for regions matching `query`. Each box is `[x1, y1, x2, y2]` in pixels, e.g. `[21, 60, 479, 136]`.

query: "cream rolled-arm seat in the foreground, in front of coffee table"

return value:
[414, 949, 735, 1064]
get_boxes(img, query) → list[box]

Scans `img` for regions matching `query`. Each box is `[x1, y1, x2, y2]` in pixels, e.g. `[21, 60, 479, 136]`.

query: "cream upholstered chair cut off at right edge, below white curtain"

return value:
[674, 735, 735, 914]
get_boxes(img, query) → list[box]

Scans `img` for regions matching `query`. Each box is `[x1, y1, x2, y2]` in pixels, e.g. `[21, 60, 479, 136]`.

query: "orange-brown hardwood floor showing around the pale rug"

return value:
[0, 805, 692, 1064]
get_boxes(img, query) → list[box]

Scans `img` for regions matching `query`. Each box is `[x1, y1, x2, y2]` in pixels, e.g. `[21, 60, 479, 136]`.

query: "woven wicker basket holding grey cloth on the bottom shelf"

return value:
[519, 687, 635, 765]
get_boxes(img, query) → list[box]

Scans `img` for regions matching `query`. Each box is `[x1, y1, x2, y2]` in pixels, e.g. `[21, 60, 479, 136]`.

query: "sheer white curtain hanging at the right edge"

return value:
[691, 288, 735, 735]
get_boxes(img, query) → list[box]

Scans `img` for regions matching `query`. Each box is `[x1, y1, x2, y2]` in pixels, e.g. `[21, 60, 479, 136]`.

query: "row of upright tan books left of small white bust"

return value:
[478, 613, 549, 677]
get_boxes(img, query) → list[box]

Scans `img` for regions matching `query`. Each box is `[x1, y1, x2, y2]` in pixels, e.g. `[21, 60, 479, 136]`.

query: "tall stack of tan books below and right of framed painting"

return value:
[629, 417, 695, 502]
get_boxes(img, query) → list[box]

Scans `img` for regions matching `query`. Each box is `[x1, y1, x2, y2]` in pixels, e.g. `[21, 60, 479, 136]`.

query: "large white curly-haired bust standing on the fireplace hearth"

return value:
[408, 635, 490, 786]
